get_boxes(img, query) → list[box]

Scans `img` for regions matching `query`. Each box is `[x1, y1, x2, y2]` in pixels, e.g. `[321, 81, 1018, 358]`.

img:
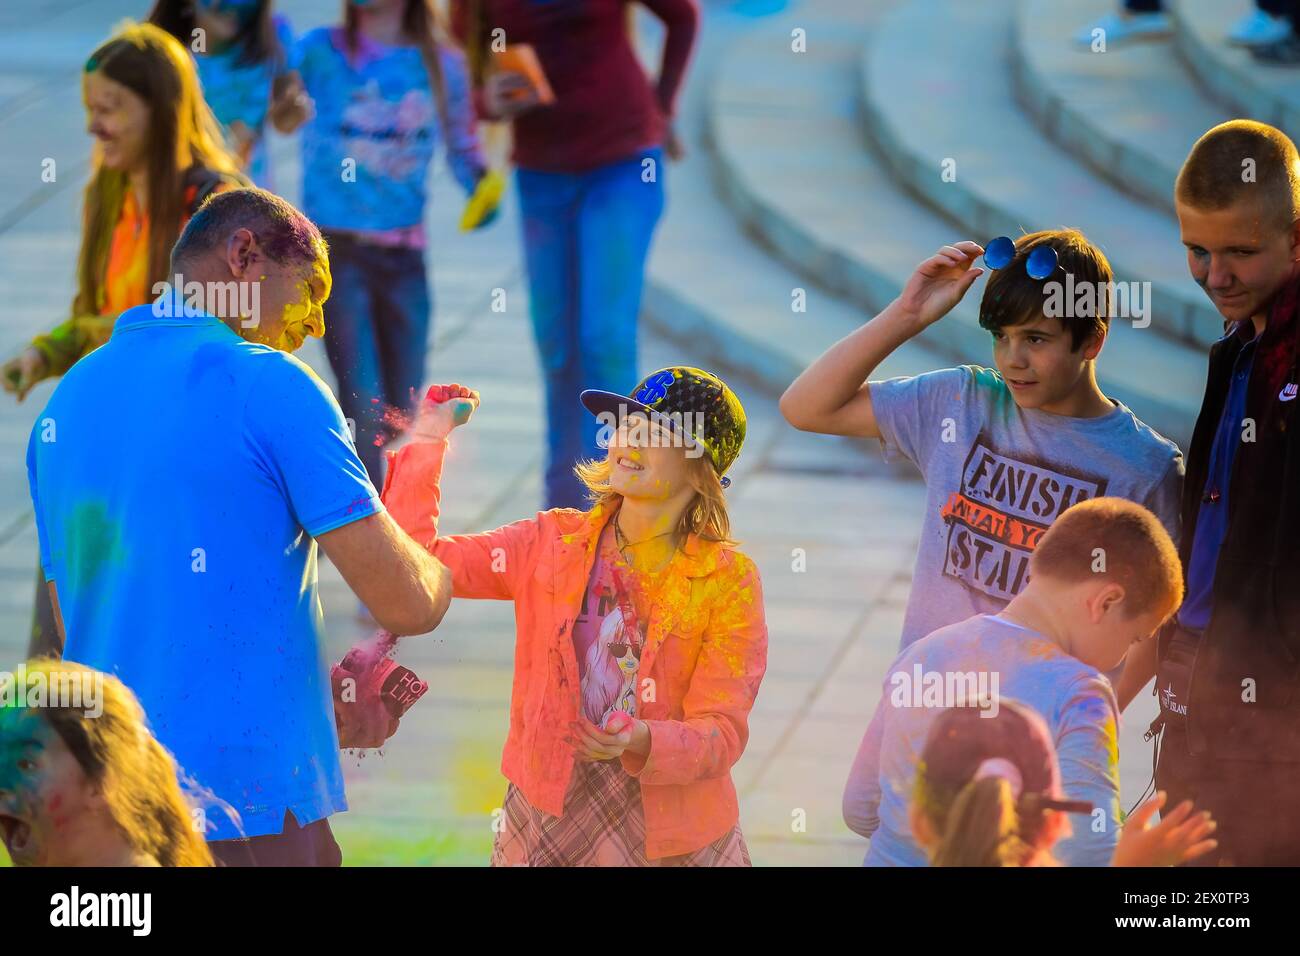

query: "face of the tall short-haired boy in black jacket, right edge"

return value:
[1177, 202, 1300, 329]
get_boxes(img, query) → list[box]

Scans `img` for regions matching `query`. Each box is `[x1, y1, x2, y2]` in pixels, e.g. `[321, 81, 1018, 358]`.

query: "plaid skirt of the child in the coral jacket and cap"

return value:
[491, 760, 751, 866]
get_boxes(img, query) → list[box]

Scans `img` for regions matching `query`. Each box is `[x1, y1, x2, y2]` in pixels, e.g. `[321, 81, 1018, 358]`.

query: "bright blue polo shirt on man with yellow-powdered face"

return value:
[27, 297, 382, 840]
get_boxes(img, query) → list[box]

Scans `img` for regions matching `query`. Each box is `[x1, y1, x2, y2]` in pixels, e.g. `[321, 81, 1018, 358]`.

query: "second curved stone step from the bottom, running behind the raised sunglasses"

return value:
[865, 0, 1222, 356]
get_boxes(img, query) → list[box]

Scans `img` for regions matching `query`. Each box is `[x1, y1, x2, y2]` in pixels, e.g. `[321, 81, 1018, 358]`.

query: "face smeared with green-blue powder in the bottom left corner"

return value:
[0, 706, 94, 866]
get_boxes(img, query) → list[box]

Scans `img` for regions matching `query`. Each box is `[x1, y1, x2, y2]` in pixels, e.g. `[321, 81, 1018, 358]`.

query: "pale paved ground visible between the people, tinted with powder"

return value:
[0, 0, 1149, 865]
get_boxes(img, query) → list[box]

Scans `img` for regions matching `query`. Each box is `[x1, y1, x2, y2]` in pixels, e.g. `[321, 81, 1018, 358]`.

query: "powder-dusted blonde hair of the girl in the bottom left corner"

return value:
[23, 658, 213, 866]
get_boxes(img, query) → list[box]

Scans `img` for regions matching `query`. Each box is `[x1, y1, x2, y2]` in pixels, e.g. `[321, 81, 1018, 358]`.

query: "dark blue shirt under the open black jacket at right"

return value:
[1178, 326, 1260, 632]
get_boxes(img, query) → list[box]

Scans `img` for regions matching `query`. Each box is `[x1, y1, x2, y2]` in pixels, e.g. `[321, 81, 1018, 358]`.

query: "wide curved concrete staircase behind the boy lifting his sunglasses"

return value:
[647, 0, 1263, 452]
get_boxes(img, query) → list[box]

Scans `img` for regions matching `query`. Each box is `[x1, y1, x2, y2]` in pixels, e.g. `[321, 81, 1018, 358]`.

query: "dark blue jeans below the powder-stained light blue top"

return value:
[325, 233, 432, 488]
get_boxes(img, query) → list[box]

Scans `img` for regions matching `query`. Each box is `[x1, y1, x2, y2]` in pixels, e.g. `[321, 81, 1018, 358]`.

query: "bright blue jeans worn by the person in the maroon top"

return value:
[516, 148, 664, 509]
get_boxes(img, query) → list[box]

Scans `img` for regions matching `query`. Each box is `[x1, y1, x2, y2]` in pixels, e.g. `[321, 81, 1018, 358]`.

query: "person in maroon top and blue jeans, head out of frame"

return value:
[451, 0, 699, 509]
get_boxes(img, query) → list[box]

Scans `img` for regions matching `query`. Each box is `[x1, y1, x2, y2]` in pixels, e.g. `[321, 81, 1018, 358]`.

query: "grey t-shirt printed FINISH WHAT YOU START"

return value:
[870, 365, 1183, 648]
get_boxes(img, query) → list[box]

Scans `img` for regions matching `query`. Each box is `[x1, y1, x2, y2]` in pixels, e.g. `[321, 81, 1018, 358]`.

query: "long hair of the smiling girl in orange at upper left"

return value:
[73, 23, 239, 315]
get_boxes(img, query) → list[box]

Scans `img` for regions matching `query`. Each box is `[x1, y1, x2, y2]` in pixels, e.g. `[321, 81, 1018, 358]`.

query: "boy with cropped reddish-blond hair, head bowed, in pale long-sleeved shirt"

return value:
[844, 498, 1183, 866]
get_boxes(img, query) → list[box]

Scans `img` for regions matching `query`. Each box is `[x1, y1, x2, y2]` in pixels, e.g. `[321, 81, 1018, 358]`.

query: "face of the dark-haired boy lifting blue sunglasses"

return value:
[992, 316, 1105, 412]
